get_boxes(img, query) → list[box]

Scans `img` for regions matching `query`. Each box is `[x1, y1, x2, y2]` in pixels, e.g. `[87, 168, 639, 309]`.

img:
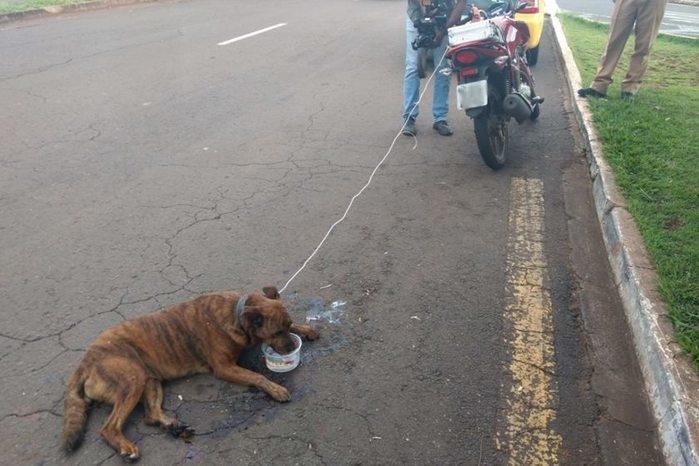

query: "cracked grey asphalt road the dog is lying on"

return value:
[0, 0, 660, 465]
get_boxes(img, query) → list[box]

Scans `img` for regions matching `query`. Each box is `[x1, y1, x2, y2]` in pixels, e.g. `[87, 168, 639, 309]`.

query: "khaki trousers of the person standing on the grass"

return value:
[591, 0, 667, 94]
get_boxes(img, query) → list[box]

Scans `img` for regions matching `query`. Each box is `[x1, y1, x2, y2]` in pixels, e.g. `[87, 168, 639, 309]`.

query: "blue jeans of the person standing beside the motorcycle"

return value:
[403, 18, 451, 123]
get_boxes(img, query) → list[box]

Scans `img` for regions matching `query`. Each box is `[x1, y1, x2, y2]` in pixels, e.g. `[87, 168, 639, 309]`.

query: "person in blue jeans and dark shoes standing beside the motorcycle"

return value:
[403, 0, 455, 136]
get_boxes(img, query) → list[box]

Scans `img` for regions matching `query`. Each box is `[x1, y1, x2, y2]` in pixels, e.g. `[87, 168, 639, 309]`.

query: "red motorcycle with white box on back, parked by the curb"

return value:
[447, 2, 544, 170]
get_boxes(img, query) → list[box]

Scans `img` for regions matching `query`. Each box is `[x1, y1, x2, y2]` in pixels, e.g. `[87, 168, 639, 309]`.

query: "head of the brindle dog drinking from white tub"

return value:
[241, 286, 296, 354]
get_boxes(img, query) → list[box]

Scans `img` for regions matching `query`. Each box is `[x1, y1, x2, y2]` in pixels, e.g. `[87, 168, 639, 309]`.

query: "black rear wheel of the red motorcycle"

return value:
[473, 86, 510, 170]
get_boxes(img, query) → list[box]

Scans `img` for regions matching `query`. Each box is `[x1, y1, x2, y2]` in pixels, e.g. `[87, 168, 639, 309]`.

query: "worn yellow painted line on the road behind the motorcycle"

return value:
[496, 178, 561, 465]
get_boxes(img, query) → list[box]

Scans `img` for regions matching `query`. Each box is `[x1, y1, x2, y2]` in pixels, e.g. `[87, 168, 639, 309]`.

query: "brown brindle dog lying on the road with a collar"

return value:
[63, 287, 319, 461]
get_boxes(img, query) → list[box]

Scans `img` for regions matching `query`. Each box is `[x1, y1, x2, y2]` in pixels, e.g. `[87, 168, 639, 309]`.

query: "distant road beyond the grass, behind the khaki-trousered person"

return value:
[557, 0, 699, 37]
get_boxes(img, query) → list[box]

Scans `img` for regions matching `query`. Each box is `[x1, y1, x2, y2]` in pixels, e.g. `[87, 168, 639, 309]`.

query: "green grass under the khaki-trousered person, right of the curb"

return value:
[560, 15, 699, 367]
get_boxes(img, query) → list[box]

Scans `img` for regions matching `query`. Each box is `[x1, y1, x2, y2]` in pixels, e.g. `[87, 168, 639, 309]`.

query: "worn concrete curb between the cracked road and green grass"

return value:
[551, 15, 699, 465]
